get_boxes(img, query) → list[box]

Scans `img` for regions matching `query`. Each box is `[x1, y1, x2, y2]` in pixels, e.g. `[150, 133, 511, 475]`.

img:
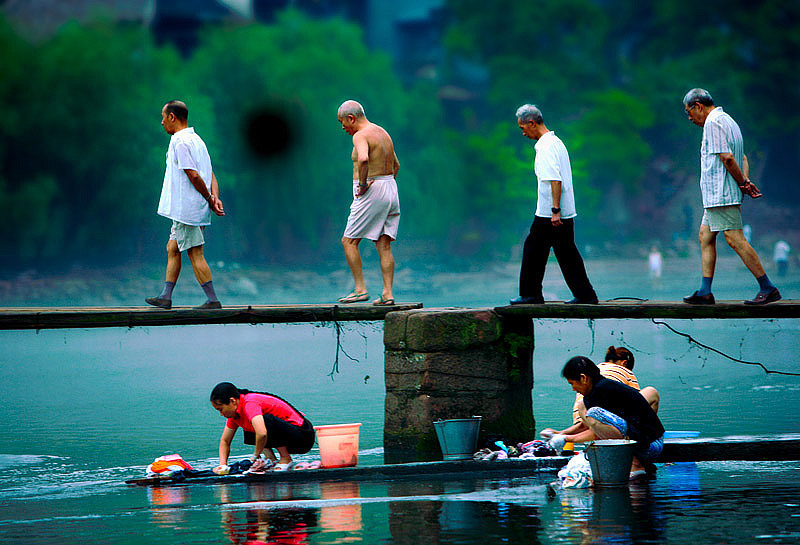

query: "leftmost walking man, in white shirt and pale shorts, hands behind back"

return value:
[145, 100, 225, 309]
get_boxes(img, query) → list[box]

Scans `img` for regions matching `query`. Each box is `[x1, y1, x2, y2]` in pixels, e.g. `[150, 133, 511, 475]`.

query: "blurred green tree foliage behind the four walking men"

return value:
[0, 0, 800, 267]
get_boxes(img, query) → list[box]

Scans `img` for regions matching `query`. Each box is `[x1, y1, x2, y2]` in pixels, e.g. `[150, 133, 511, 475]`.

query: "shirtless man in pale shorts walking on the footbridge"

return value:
[338, 100, 400, 305]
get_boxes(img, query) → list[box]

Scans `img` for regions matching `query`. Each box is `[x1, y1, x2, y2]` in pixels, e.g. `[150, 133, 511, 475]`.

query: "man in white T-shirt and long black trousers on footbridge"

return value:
[511, 104, 597, 305]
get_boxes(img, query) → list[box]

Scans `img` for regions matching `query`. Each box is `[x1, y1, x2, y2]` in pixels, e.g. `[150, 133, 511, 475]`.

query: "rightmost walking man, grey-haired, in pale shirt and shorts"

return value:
[683, 89, 781, 305]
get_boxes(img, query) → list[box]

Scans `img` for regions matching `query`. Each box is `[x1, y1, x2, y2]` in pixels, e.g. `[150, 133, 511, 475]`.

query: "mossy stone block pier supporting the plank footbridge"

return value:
[383, 308, 535, 463]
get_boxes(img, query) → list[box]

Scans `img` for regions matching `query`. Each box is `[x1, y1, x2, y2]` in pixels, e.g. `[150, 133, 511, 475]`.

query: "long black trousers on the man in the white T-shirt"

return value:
[519, 216, 597, 299]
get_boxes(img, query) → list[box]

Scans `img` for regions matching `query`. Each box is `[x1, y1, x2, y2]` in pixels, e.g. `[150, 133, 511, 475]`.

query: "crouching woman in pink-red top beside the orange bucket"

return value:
[211, 382, 316, 474]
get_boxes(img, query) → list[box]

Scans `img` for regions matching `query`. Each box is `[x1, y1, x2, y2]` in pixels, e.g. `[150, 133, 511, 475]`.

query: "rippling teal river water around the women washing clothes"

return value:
[0, 262, 800, 544]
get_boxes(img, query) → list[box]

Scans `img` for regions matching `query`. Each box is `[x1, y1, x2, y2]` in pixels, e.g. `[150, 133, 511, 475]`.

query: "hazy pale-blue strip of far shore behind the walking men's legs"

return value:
[0, 253, 800, 307]
